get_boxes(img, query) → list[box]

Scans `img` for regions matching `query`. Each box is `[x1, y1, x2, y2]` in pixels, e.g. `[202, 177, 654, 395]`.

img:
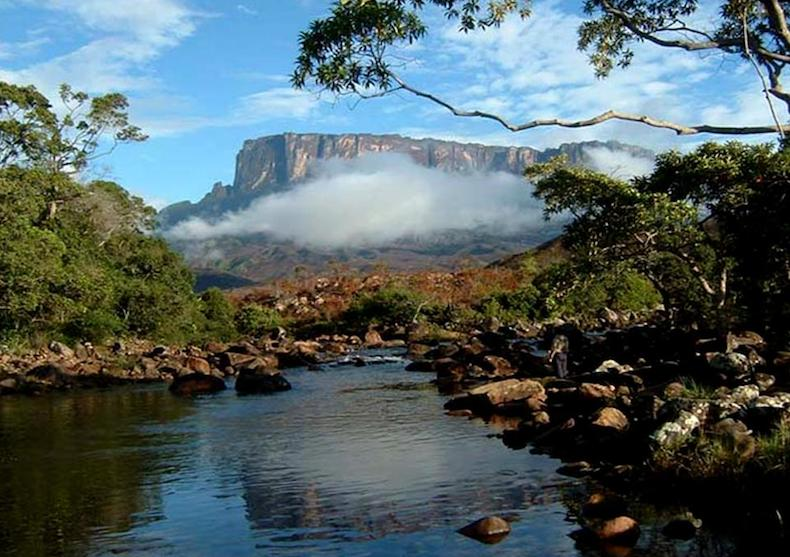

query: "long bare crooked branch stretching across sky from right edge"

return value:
[390, 74, 790, 135]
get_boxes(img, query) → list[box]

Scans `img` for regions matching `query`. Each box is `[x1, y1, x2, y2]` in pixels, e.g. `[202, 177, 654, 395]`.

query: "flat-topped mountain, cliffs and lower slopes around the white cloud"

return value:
[159, 133, 653, 280]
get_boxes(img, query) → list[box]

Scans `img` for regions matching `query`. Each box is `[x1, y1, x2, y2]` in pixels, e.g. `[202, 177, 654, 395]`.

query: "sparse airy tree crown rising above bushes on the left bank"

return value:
[0, 82, 147, 173]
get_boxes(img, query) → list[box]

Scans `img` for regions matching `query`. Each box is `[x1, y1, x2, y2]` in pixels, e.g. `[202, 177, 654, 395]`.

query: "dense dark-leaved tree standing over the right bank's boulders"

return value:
[527, 142, 790, 337]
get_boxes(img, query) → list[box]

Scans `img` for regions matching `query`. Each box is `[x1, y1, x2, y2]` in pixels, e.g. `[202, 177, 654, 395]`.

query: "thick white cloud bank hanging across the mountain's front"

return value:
[165, 153, 542, 247]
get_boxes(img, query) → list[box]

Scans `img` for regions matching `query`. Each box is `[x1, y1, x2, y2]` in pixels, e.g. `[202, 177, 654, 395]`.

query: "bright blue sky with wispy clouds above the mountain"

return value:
[0, 0, 770, 205]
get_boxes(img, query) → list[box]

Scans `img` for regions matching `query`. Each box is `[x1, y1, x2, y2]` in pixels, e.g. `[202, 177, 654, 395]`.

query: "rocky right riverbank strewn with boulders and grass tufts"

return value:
[408, 326, 790, 554]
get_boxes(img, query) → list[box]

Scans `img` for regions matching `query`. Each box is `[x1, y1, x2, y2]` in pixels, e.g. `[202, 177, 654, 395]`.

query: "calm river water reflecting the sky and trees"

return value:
[0, 354, 736, 556]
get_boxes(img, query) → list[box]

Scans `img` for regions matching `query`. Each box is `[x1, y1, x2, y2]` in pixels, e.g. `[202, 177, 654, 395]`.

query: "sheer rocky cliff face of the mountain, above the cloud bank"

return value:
[159, 133, 650, 228]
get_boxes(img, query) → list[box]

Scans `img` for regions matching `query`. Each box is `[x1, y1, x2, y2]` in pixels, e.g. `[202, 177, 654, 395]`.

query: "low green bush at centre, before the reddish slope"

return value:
[343, 287, 426, 328]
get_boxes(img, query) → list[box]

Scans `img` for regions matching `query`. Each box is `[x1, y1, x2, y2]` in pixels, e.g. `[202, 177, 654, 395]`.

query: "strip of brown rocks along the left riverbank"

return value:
[0, 330, 404, 395]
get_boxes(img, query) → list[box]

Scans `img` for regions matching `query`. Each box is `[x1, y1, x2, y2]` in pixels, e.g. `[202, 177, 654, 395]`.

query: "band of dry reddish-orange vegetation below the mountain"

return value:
[230, 267, 524, 320]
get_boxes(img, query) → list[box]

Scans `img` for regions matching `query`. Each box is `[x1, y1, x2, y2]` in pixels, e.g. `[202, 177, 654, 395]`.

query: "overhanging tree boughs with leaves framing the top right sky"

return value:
[292, 0, 790, 135]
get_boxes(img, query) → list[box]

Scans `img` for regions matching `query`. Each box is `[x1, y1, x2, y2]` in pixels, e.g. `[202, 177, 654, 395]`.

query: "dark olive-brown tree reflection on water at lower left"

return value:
[0, 389, 196, 556]
